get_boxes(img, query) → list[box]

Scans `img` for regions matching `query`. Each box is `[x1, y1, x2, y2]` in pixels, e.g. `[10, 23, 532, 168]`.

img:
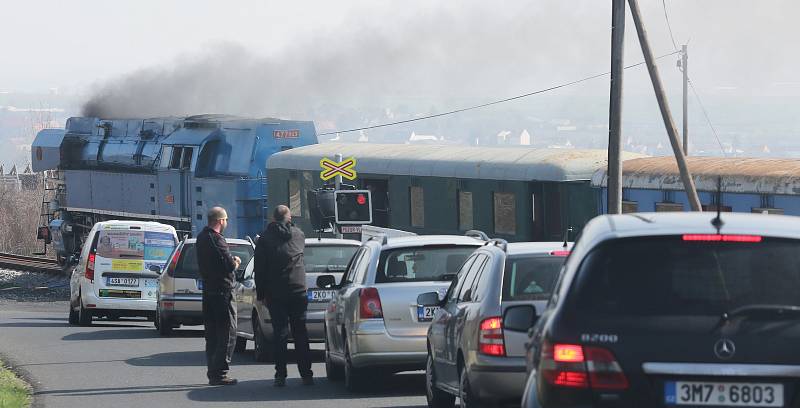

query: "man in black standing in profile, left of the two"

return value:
[195, 207, 242, 385]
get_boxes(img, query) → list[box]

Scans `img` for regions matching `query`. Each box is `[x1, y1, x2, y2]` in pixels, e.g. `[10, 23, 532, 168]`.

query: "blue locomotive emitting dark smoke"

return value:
[31, 115, 317, 261]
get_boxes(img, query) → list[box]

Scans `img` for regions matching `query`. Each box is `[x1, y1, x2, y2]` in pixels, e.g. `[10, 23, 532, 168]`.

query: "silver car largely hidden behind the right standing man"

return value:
[236, 238, 361, 362]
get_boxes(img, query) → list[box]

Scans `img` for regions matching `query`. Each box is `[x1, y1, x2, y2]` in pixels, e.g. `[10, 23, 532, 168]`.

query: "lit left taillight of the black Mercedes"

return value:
[541, 344, 628, 391]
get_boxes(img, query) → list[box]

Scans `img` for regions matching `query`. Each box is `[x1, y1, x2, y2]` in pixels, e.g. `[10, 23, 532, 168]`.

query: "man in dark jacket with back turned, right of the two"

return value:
[254, 205, 314, 387]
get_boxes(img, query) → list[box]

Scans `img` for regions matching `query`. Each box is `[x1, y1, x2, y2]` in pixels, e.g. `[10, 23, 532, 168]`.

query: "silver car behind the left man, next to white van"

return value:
[155, 238, 253, 336]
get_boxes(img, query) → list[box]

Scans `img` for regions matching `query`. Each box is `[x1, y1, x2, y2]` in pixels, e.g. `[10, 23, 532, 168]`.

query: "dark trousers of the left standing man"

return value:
[203, 292, 236, 380]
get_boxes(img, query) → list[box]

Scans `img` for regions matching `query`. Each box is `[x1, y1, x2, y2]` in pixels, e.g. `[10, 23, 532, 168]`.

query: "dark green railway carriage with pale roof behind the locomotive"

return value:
[267, 143, 644, 241]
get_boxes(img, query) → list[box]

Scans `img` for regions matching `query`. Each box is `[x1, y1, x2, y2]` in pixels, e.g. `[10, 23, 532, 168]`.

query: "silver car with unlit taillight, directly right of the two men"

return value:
[318, 235, 484, 390]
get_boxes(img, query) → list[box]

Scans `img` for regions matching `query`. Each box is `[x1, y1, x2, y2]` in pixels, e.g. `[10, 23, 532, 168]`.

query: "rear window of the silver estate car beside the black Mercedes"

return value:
[503, 255, 566, 301]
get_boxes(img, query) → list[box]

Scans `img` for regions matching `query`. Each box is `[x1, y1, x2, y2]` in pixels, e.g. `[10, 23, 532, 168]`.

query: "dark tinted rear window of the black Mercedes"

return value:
[576, 235, 800, 316]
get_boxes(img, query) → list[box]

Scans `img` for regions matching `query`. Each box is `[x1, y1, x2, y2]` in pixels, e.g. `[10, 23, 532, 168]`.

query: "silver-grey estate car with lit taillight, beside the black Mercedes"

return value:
[417, 240, 571, 408]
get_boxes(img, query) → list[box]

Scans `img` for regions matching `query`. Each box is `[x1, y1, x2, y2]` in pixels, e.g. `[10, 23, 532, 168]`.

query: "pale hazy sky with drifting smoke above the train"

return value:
[0, 0, 800, 113]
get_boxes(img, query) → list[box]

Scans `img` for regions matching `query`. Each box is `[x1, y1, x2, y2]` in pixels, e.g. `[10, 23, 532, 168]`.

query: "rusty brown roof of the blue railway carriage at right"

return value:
[592, 156, 800, 195]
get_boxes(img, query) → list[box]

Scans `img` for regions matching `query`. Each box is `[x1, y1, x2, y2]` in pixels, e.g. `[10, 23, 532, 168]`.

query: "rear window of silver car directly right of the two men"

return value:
[375, 245, 476, 283]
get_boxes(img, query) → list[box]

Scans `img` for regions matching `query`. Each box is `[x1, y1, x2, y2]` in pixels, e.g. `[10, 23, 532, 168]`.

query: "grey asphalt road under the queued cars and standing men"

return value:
[0, 302, 426, 408]
